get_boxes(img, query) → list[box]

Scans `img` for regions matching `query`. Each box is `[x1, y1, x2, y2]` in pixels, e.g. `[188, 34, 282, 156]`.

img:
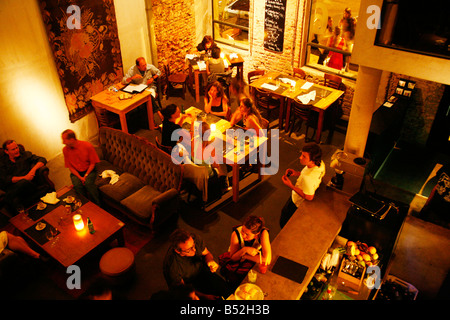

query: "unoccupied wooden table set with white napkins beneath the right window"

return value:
[250, 71, 344, 143]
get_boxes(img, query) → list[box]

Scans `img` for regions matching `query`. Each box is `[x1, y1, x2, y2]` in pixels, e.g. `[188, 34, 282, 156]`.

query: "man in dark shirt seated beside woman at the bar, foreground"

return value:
[163, 229, 230, 299]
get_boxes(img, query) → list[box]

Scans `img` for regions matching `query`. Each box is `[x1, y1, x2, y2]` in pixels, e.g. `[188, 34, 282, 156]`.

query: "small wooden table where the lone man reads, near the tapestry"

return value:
[91, 84, 155, 133]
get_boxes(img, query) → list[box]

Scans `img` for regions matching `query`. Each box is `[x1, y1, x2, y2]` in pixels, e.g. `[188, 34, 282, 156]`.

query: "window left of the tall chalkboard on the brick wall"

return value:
[212, 0, 250, 49]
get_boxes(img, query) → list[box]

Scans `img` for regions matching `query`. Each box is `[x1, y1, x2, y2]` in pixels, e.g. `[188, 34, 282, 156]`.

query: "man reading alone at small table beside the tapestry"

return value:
[122, 57, 163, 120]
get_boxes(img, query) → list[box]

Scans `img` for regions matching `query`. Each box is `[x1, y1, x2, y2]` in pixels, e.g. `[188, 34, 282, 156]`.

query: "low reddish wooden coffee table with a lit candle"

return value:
[10, 187, 125, 268]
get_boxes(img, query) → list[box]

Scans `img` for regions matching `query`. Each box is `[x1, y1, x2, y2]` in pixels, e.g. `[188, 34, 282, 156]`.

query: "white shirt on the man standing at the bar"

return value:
[292, 161, 325, 207]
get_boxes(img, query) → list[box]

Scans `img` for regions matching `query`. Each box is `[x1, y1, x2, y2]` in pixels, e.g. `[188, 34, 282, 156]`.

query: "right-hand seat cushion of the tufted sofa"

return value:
[120, 185, 161, 219]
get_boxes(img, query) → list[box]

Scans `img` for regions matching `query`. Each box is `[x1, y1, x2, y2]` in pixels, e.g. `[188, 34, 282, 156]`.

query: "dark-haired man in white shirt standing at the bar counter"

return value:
[280, 143, 325, 228]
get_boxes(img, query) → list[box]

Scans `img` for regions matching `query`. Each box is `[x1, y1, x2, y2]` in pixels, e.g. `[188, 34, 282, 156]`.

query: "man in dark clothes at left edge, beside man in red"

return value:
[0, 140, 50, 214]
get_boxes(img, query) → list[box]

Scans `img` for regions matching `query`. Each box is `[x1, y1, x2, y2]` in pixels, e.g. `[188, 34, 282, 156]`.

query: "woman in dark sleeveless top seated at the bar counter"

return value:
[219, 215, 272, 284]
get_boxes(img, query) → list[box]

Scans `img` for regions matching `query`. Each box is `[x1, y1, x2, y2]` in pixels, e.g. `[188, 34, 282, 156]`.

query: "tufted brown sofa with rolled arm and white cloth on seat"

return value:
[96, 127, 183, 230]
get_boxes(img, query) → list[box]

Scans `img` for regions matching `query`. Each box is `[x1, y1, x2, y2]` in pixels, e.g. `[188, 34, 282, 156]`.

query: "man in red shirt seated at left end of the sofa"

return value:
[61, 129, 101, 205]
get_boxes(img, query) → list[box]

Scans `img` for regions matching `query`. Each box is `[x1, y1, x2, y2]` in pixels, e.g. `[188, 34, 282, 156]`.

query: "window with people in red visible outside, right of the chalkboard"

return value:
[306, 0, 360, 79]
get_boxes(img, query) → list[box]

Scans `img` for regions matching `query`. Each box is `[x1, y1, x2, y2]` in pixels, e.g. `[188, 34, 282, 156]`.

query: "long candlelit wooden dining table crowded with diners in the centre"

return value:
[186, 107, 268, 202]
